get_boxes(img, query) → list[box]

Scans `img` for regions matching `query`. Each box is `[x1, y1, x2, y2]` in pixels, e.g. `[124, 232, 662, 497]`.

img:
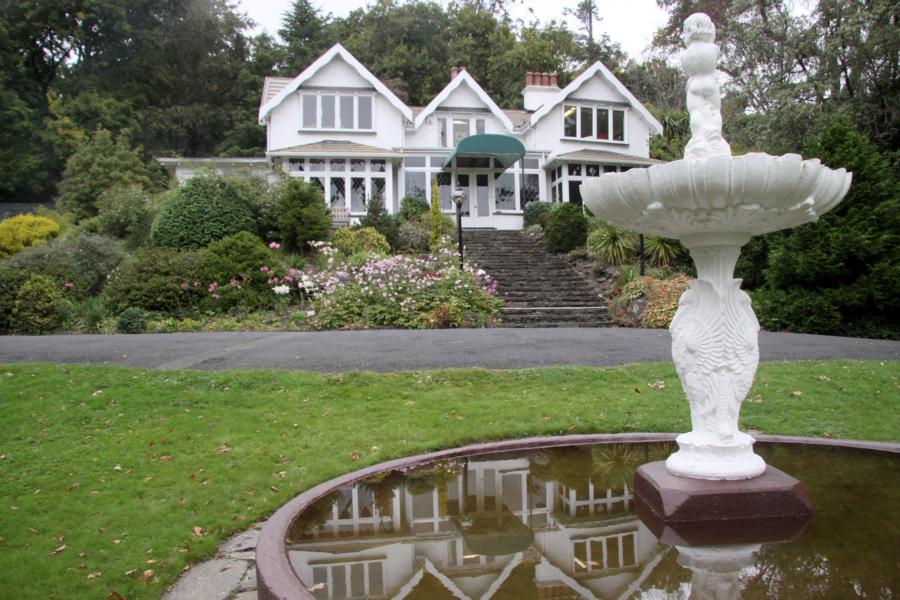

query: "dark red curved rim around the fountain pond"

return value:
[256, 433, 900, 600]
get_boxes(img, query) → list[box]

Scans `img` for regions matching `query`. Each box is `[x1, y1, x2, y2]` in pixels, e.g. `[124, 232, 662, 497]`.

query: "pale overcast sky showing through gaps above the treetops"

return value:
[238, 0, 666, 59]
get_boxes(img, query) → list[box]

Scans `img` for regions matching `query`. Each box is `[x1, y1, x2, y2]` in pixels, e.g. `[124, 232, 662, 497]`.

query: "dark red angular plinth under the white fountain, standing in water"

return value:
[634, 461, 812, 525]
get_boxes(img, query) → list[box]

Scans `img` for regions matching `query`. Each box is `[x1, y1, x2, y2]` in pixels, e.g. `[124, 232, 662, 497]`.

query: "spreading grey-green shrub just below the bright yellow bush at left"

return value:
[11, 233, 126, 298]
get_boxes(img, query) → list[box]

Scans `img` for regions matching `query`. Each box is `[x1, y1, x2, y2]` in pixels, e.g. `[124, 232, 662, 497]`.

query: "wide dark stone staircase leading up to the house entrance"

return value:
[463, 229, 609, 327]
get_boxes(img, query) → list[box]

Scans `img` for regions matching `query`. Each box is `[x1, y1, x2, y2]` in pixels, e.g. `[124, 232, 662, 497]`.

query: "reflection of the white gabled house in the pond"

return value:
[289, 458, 660, 599]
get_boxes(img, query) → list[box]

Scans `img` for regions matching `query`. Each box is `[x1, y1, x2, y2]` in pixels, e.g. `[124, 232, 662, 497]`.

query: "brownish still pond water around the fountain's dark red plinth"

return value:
[286, 443, 900, 600]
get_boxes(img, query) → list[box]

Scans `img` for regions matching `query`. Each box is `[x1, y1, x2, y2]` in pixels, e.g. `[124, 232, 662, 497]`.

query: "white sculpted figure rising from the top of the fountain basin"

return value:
[681, 13, 731, 159]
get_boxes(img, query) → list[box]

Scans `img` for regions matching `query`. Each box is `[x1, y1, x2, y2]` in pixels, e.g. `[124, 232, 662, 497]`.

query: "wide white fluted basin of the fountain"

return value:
[582, 153, 851, 241]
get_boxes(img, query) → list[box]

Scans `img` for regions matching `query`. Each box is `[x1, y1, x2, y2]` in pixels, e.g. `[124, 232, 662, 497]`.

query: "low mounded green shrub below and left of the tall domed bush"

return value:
[103, 248, 208, 315]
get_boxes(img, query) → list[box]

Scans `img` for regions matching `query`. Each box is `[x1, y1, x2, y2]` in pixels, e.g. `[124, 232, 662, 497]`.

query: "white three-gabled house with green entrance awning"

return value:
[160, 44, 662, 229]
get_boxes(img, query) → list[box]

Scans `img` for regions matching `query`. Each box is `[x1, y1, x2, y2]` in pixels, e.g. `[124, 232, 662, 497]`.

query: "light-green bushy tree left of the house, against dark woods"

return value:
[59, 129, 153, 219]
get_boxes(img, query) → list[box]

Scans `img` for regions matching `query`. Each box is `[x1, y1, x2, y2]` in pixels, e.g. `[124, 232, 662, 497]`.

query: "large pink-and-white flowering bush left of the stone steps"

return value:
[298, 244, 500, 328]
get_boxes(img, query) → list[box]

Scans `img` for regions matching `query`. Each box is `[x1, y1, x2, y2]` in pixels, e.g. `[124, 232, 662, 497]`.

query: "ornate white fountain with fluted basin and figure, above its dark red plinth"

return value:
[582, 13, 851, 480]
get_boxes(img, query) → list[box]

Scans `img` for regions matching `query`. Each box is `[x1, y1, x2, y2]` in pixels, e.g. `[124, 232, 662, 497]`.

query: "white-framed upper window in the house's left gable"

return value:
[300, 90, 372, 131]
